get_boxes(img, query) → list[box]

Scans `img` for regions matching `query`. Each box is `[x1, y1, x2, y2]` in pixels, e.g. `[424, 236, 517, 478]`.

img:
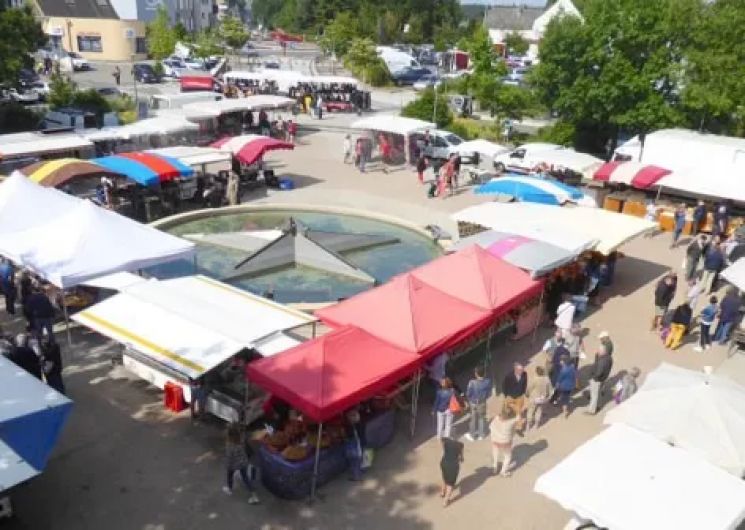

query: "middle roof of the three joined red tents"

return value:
[316, 274, 492, 356]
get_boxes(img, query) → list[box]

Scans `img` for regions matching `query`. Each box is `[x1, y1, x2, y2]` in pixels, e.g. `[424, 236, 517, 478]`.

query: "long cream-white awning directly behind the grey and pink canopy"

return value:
[452, 202, 656, 254]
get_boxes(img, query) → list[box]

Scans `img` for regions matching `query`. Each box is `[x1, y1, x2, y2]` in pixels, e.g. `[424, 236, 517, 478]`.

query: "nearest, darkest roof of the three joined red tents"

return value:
[247, 326, 421, 422]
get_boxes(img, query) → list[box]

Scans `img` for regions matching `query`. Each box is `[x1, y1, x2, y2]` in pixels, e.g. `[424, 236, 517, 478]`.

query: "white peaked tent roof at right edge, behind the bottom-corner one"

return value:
[604, 363, 745, 477]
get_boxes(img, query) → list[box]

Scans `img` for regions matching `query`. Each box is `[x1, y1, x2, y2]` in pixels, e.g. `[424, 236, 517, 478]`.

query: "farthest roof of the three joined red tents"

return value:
[409, 245, 543, 315]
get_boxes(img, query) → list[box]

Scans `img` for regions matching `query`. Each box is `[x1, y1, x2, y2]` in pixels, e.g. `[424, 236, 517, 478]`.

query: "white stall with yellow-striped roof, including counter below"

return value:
[73, 276, 314, 423]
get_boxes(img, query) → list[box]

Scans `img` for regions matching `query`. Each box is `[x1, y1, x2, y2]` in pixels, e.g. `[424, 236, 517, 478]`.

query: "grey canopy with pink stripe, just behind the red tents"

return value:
[449, 230, 577, 278]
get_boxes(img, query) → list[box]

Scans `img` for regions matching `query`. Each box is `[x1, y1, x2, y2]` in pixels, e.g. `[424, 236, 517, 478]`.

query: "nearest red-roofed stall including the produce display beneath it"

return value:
[248, 326, 421, 499]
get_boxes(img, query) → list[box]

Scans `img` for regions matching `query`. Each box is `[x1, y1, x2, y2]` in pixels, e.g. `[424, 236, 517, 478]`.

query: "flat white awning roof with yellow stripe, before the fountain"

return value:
[72, 276, 314, 378]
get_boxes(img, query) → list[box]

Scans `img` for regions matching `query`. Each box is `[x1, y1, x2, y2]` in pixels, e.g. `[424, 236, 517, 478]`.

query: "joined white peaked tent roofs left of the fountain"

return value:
[0, 174, 194, 288]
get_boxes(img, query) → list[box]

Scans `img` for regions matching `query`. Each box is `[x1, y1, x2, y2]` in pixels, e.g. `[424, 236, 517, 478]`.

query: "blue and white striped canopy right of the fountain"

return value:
[474, 174, 592, 205]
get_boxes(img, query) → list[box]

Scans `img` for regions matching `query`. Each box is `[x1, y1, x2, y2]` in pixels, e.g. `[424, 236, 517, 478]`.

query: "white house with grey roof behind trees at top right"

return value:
[484, 0, 582, 57]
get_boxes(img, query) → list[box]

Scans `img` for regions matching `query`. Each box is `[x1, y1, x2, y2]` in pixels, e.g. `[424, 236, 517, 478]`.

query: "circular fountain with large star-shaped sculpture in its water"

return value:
[150, 204, 441, 304]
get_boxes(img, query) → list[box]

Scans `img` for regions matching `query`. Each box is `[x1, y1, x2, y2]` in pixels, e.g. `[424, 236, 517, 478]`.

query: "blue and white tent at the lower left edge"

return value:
[0, 356, 72, 508]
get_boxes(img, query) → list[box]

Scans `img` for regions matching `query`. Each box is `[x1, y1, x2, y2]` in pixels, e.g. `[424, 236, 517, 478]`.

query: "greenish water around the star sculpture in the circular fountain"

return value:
[158, 210, 441, 303]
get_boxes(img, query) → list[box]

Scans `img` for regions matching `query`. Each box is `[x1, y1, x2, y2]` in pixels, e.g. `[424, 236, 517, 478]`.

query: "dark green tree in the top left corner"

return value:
[0, 2, 47, 84]
